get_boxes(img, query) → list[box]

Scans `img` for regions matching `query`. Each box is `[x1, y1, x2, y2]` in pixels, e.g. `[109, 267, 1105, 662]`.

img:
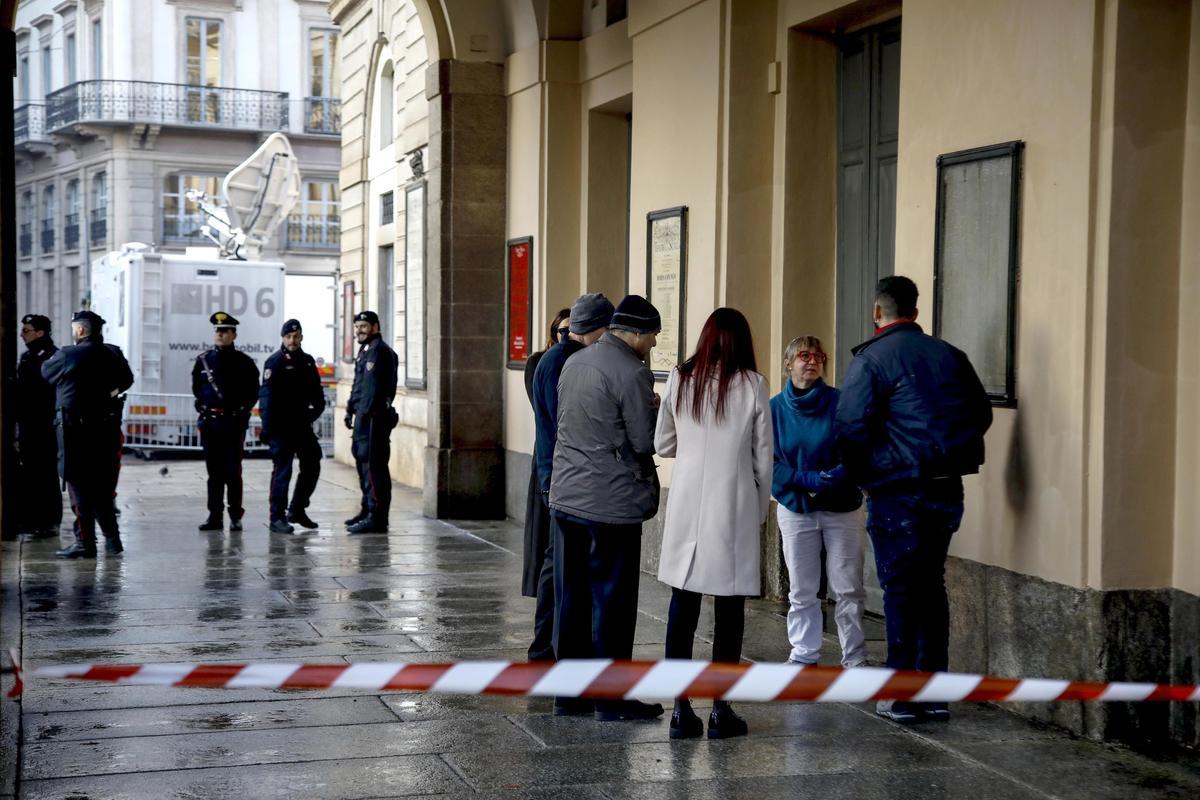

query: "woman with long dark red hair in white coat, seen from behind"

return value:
[654, 308, 773, 739]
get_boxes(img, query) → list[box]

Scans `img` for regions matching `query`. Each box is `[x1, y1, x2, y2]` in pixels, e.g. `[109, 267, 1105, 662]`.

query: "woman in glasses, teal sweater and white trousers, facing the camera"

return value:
[770, 336, 866, 667]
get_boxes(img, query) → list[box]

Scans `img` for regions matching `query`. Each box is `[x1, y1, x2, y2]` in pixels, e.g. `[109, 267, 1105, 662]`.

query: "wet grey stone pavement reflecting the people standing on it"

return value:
[0, 459, 1200, 800]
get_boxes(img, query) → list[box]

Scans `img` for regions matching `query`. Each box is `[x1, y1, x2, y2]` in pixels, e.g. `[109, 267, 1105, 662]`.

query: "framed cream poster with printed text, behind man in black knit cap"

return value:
[646, 205, 688, 380]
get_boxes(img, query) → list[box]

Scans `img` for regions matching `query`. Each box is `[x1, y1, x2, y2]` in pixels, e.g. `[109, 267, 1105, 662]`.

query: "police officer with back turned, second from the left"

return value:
[42, 311, 133, 559]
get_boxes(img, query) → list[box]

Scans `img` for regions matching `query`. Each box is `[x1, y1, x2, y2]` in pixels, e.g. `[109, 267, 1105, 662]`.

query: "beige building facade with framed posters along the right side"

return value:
[331, 0, 1200, 745]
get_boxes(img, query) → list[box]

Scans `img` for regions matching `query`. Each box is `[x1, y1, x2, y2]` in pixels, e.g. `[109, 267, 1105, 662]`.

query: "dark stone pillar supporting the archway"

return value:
[425, 61, 508, 519]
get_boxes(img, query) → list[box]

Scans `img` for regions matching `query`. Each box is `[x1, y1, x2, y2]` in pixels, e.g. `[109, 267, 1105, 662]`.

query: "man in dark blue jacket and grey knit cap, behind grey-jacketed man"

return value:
[528, 293, 614, 661]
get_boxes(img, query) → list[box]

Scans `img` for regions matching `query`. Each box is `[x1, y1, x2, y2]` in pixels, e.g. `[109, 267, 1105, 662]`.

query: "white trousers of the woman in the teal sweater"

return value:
[779, 504, 866, 667]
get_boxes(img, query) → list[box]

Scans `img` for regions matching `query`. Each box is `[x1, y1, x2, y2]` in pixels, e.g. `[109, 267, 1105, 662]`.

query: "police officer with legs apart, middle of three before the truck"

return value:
[258, 319, 325, 534]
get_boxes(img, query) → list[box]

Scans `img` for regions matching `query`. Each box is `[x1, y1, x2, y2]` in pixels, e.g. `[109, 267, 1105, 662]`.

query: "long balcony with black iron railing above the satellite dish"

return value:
[46, 80, 288, 131]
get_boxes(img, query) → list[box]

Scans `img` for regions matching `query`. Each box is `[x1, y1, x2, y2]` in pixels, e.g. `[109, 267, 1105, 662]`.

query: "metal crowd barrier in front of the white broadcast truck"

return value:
[124, 389, 334, 456]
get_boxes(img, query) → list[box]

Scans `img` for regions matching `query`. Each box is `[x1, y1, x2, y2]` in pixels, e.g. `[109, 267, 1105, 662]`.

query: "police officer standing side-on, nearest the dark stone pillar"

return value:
[346, 311, 400, 534]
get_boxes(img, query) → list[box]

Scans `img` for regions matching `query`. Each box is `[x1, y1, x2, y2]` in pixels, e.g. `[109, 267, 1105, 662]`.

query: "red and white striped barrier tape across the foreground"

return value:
[9, 660, 1200, 703]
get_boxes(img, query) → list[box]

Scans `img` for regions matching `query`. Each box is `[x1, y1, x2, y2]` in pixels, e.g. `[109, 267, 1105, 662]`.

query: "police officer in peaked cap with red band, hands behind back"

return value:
[192, 311, 258, 531]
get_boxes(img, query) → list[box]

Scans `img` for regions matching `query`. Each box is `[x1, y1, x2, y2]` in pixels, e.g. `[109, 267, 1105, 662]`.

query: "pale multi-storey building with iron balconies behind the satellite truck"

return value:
[13, 0, 341, 340]
